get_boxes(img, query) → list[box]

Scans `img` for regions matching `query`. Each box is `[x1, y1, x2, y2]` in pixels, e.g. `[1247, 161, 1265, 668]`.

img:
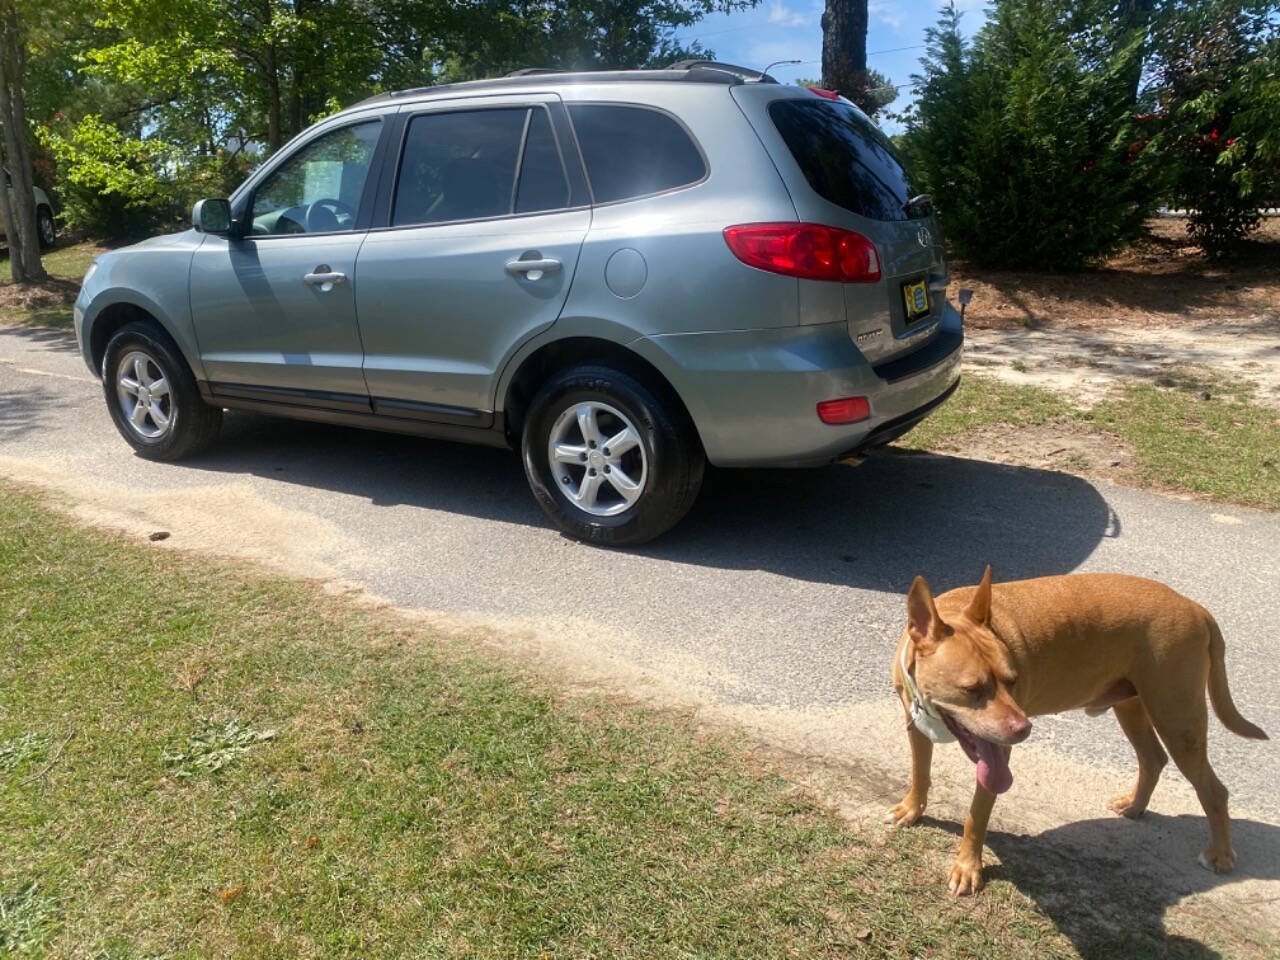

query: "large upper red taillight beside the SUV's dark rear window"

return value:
[724, 223, 879, 283]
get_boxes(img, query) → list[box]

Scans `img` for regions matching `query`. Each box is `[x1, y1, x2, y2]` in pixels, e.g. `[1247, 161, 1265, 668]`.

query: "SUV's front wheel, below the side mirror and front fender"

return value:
[102, 323, 223, 461]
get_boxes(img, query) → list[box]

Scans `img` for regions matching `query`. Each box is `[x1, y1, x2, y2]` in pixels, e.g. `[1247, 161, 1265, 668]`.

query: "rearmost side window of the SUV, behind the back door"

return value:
[568, 104, 707, 204]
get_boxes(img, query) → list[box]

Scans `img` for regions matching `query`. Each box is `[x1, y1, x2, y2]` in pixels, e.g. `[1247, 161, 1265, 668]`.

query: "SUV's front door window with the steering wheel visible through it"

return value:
[251, 119, 381, 236]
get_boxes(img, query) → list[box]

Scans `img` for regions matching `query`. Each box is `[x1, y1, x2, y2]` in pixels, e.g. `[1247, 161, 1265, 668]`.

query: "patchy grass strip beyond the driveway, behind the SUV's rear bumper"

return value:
[899, 371, 1280, 509]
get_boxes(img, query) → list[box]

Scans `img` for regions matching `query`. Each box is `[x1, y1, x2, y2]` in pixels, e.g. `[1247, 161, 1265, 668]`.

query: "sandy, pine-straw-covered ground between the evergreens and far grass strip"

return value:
[951, 216, 1280, 410]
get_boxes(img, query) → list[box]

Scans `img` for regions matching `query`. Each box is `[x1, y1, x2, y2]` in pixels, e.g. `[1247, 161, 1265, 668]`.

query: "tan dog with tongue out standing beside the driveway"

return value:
[886, 567, 1267, 893]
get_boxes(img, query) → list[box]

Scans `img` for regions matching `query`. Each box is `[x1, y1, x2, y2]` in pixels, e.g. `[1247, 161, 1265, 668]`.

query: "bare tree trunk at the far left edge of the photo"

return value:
[0, 0, 49, 283]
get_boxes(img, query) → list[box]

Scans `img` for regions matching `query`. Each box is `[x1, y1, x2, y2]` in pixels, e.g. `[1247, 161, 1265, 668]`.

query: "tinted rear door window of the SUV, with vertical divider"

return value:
[392, 106, 568, 227]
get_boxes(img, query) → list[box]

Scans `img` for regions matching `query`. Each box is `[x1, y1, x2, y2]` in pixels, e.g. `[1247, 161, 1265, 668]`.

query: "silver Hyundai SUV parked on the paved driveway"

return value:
[76, 61, 963, 545]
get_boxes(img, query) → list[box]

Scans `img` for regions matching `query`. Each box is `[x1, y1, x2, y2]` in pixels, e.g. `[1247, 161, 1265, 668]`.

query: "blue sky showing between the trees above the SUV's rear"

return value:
[676, 0, 986, 132]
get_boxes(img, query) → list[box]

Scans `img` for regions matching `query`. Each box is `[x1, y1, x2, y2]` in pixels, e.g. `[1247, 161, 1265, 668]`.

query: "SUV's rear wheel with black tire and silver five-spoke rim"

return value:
[521, 365, 707, 547]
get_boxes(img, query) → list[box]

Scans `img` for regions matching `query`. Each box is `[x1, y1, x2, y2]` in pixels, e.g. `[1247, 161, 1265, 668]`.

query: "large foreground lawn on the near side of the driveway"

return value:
[0, 485, 1080, 960]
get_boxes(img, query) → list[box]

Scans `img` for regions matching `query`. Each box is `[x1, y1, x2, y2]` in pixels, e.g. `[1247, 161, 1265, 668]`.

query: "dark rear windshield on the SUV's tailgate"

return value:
[769, 99, 913, 220]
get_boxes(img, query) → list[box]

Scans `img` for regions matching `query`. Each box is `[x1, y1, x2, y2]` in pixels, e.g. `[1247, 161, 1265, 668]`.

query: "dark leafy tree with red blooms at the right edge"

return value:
[1149, 0, 1280, 256]
